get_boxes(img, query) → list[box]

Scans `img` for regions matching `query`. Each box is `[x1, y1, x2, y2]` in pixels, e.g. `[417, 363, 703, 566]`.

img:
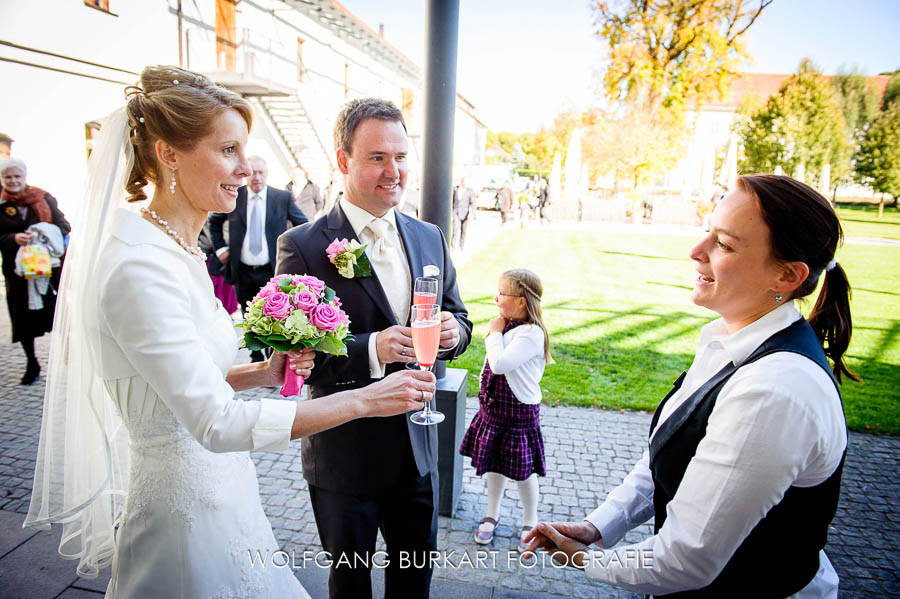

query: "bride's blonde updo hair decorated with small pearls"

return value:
[125, 66, 253, 202]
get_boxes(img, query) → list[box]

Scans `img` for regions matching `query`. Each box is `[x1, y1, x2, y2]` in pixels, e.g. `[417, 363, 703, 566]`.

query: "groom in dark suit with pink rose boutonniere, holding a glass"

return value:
[275, 98, 472, 599]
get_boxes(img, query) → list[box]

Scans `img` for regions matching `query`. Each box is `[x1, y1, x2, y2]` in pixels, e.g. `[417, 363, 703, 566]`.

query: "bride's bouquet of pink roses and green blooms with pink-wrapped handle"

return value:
[238, 275, 353, 397]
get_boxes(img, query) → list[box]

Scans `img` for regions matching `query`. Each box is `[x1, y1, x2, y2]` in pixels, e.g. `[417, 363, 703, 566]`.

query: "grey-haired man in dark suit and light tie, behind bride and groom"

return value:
[209, 156, 306, 362]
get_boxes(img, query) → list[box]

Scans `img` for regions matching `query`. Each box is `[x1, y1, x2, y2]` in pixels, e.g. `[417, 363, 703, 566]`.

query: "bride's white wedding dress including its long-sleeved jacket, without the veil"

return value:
[99, 211, 308, 599]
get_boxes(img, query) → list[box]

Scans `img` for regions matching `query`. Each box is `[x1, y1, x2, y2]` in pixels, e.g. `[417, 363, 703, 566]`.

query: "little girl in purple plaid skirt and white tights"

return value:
[459, 269, 553, 551]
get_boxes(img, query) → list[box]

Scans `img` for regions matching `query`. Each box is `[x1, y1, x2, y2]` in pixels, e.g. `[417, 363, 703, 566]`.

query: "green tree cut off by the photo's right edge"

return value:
[856, 102, 900, 204]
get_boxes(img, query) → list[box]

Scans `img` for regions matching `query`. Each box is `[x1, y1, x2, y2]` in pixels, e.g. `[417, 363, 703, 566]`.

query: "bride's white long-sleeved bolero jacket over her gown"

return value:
[96, 209, 296, 452]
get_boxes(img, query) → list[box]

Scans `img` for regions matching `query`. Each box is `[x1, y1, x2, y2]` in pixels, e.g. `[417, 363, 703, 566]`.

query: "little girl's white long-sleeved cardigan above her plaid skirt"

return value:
[484, 324, 547, 405]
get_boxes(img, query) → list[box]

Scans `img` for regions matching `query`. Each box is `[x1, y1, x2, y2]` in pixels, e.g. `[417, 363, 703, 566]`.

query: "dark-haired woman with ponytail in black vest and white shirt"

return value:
[529, 175, 859, 598]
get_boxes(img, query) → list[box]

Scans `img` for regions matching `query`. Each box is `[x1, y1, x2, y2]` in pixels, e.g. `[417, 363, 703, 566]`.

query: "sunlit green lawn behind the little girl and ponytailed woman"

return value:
[455, 225, 900, 433]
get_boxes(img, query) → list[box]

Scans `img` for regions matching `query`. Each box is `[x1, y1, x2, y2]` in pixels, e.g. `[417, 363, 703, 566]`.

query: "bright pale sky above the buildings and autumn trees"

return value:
[339, 0, 900, 132]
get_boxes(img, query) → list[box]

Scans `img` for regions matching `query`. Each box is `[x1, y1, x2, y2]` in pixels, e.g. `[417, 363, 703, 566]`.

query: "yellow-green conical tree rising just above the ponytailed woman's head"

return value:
[739, 59, 852, 185]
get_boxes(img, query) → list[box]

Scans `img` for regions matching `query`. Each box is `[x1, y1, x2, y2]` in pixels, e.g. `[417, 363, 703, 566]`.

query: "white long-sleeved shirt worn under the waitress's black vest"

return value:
[585, 302, 847, 599]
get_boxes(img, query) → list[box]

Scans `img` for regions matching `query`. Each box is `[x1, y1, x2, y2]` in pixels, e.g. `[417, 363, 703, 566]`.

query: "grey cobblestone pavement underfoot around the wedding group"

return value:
[0, 294, 900, 598]
